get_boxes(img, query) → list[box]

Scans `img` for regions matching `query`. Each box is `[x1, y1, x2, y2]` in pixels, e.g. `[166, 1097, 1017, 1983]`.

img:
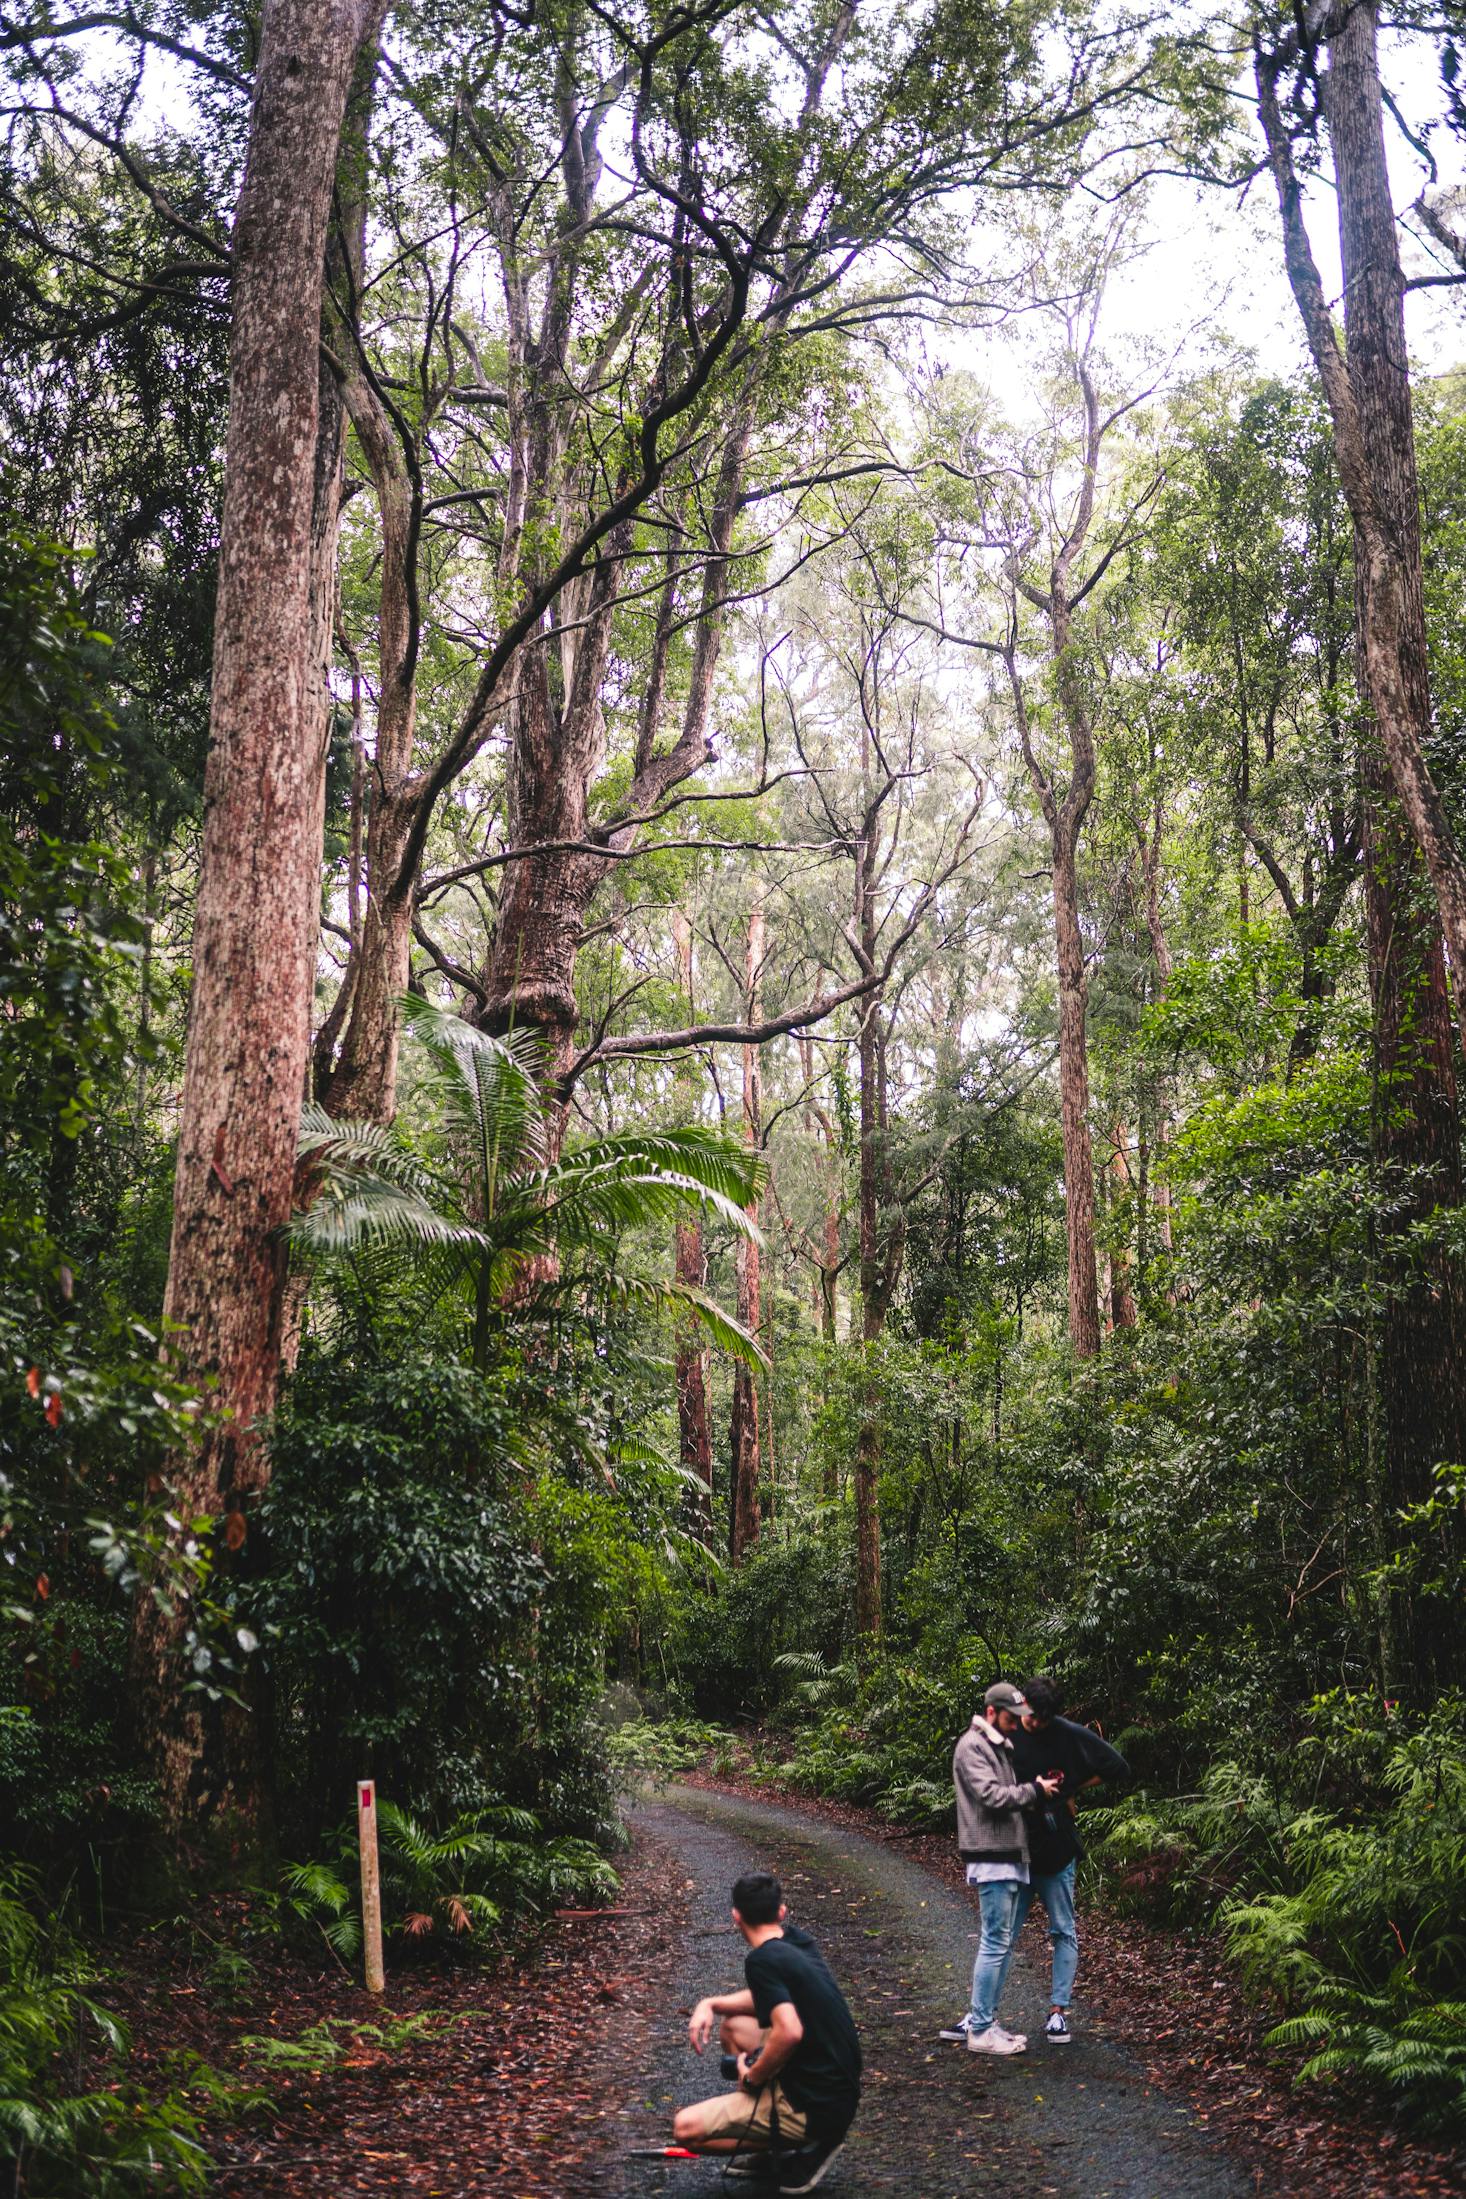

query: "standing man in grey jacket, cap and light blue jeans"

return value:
[941, 1680, 1059, 2054]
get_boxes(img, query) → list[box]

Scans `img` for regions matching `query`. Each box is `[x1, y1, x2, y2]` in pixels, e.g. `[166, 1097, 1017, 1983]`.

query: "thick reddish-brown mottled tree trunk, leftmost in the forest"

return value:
[134, 0, 382, 1832]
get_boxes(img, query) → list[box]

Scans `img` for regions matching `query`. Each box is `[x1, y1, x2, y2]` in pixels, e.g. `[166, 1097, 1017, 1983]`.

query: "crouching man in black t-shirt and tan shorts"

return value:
[673, 1871, 859, 2192]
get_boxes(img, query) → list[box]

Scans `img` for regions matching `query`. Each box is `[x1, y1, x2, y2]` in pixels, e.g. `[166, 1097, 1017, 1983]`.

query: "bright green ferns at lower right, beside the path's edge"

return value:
[1095, 1695, 1466, 2131]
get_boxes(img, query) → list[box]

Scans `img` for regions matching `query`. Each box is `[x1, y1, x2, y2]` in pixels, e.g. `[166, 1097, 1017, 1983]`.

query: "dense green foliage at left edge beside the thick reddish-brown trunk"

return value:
[0, 526, 231, 1871]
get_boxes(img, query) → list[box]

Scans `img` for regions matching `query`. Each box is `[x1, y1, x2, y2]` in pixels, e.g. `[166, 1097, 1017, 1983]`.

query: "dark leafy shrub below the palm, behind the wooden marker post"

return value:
[251, 1355, 611, 1852]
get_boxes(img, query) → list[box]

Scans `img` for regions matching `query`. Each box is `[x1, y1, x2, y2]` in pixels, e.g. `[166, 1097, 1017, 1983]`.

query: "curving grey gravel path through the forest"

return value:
[596, 1788, 1257, 2199]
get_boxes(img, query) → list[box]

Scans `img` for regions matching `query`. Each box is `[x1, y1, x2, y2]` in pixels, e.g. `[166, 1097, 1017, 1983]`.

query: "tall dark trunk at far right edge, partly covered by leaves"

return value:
[1328, 4, 1466, 1687]
